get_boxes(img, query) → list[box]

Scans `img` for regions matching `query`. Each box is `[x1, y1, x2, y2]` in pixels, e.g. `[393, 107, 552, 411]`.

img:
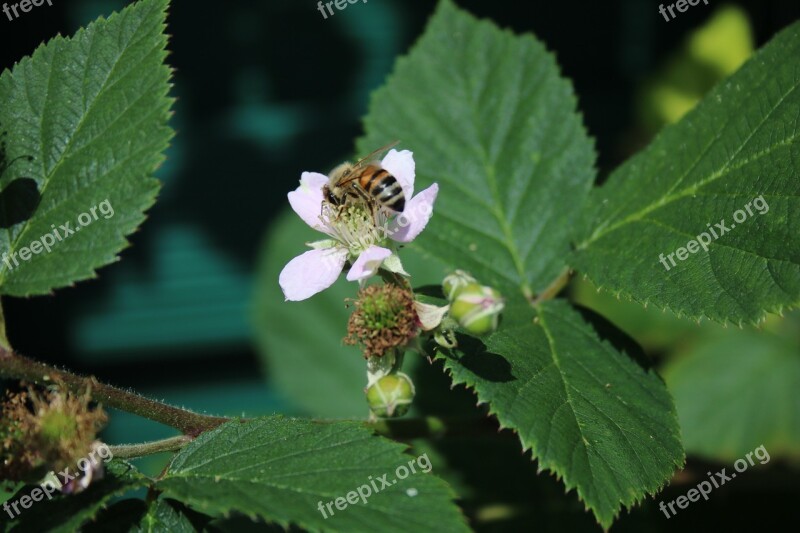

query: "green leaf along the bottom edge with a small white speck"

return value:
[158, 417, 468, 532]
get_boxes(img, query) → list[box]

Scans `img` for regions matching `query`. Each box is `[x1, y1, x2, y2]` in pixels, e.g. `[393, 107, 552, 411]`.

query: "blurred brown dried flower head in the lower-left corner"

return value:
[0, 386, 107, 481]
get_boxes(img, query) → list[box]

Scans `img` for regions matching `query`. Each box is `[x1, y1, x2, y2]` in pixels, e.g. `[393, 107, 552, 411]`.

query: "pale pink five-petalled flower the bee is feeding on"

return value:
[279, 150, 439, 301]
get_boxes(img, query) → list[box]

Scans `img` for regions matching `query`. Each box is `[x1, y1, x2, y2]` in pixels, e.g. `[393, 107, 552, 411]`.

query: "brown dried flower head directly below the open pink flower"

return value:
[344, 284, 419, 357]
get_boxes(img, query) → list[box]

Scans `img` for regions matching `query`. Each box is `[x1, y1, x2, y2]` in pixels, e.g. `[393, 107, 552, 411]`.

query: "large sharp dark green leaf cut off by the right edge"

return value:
[571, 23, 800, 323]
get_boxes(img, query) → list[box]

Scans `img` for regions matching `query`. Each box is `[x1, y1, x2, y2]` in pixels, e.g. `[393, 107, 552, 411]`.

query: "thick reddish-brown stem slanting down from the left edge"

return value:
[0, 347, 229, 437]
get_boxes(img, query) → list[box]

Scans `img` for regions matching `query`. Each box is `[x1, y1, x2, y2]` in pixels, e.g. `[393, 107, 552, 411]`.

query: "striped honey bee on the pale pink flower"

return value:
[322, 141, 406, 218]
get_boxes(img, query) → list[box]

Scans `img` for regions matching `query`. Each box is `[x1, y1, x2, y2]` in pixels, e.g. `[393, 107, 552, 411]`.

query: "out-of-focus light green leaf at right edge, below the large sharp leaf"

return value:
[664, 323, 800, 463]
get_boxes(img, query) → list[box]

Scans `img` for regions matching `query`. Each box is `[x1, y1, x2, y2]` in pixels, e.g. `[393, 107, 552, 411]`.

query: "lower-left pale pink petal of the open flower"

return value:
[278, 248, 347, 302]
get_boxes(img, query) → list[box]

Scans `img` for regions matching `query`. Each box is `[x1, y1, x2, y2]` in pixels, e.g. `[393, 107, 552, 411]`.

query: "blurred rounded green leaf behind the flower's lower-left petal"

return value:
[254, 209, 447, 418]
